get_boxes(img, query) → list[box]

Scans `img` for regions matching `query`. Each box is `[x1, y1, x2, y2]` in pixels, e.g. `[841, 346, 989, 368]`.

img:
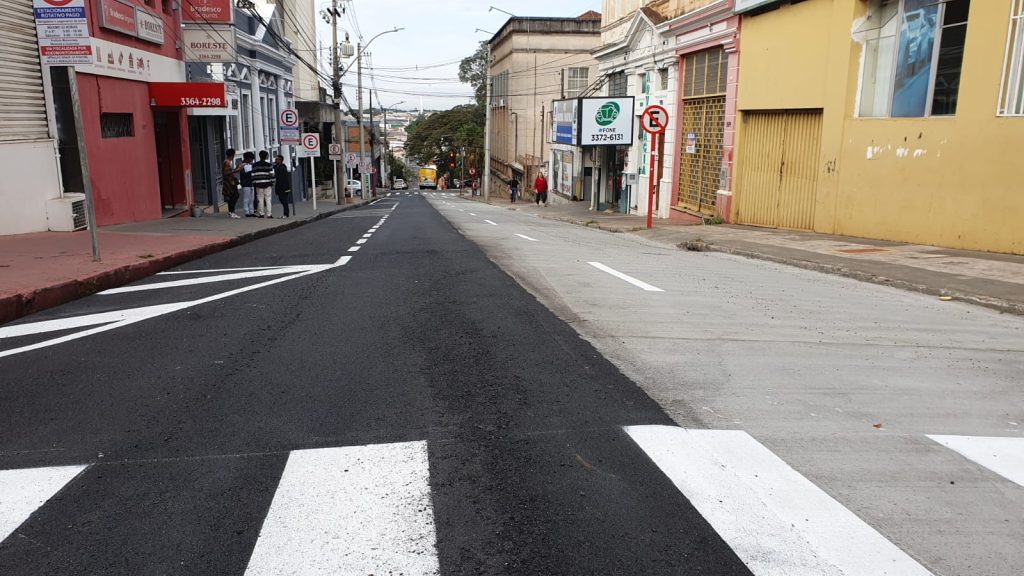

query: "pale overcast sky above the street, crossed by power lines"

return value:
[314, 0, 601, 111]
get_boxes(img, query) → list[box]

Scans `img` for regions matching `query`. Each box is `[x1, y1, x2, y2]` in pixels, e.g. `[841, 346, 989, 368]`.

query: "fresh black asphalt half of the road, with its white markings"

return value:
[0, 193, 751, 576]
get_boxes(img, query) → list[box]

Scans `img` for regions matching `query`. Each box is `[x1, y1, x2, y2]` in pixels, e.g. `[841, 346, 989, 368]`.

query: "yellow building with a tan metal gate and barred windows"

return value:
[731, 0, 1024, 254]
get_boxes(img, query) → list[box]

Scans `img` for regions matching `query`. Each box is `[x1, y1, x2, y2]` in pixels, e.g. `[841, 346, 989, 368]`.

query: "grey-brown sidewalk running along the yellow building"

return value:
[467, 196, 1024, 315]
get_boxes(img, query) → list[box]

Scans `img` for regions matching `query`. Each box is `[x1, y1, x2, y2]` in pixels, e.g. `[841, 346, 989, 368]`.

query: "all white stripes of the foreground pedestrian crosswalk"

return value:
[0, 425, 1024, 576]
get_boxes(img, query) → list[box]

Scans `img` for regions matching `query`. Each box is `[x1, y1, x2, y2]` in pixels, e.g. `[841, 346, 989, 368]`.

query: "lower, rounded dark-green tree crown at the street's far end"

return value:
[406, 105, 485, 174]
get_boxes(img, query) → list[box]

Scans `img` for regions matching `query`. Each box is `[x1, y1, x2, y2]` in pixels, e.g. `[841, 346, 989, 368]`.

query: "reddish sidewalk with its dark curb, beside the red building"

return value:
[0, 195, 365, 324]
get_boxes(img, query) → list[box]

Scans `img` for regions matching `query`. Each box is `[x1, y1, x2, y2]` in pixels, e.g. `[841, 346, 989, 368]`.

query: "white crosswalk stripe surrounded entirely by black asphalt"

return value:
[246, 442, 440, 576]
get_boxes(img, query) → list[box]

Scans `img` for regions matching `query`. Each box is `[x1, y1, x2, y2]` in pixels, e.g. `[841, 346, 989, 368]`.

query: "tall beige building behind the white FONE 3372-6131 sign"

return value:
[488, 12, 601, 198]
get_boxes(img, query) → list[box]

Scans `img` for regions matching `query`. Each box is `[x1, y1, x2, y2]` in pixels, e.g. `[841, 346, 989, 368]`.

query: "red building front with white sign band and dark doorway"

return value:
[51, 0, 193, 225]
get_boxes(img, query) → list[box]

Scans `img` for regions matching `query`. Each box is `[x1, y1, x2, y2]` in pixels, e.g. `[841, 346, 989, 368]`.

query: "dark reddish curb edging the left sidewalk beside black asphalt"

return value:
[0, 200, 372, 324]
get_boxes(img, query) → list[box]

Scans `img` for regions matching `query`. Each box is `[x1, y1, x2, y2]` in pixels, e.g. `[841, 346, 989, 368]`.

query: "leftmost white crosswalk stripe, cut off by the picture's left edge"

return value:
[0, 466, 88, 542]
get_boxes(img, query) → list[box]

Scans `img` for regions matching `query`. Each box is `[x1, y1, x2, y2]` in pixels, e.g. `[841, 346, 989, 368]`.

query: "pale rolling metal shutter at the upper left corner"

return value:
[0, 0, 49, 142]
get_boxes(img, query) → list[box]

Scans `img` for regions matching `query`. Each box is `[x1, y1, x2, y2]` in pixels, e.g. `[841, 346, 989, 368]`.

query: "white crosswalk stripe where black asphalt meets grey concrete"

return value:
[626, 426, 931, 576]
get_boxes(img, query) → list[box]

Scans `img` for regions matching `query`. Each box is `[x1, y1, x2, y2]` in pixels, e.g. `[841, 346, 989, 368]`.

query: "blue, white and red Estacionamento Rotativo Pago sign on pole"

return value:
[33, 0, 92, 66]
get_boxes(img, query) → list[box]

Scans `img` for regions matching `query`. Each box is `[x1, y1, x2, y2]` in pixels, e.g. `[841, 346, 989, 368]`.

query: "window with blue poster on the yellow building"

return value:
[857, 0, 971, 118]
